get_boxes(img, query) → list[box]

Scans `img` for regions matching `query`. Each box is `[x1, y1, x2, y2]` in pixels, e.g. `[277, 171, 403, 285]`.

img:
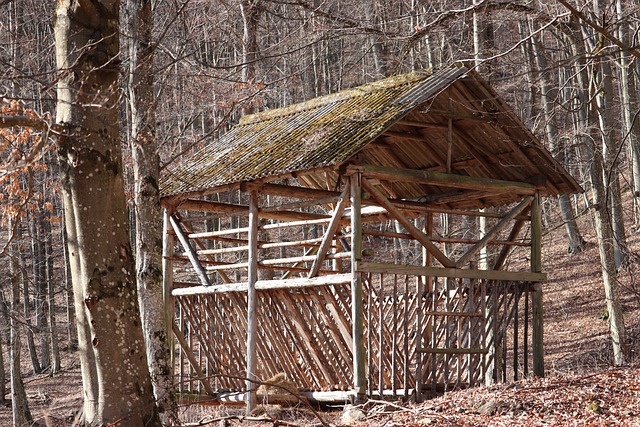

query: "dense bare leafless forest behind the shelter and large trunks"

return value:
[0, 0, 640, 426]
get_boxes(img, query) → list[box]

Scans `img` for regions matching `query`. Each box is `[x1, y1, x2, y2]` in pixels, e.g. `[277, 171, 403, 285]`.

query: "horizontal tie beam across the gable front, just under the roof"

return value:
[359, 165, 536, 196]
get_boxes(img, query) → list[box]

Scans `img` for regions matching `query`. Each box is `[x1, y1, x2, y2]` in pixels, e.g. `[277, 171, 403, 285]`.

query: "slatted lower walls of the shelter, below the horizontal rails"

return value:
[176, 273, 531, 396]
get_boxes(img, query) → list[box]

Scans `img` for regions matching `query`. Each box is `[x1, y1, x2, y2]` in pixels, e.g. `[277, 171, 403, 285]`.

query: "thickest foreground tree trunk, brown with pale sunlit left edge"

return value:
[54, 0, 161, 427]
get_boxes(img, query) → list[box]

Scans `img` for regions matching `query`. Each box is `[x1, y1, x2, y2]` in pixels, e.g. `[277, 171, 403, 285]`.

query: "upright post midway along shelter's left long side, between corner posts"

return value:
[245, 189, 258, 415]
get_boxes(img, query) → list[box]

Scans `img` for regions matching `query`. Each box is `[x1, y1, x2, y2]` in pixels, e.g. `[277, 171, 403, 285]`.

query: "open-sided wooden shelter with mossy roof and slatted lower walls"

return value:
[161, 67, 581, 407]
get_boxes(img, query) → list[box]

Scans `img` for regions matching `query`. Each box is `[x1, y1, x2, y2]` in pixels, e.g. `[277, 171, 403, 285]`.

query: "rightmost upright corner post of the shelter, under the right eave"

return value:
[531, 194, 544, 378]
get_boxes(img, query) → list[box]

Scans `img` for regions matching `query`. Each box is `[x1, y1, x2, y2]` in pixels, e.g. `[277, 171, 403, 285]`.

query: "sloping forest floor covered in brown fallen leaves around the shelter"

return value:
[0, 204, 640, 427]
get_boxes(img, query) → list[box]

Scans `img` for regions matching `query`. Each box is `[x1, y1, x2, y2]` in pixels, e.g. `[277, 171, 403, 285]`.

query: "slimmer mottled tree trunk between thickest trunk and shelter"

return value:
[126, 0, 179, 425]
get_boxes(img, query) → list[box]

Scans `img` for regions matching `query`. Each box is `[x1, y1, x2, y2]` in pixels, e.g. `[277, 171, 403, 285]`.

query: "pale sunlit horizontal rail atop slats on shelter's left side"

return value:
[171, 273, 351, 296]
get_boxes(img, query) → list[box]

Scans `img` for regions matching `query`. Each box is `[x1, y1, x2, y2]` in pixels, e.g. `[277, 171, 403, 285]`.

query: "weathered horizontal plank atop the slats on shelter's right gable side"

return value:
[358, 262, 547, 282]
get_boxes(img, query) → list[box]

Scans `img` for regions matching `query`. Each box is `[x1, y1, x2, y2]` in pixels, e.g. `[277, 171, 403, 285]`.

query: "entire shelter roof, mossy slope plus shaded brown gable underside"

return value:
[161, 67, 581, 207]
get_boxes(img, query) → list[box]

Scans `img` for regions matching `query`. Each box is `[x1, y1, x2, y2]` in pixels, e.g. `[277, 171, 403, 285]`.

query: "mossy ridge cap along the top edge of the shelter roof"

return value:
[238, 68, 433, 126]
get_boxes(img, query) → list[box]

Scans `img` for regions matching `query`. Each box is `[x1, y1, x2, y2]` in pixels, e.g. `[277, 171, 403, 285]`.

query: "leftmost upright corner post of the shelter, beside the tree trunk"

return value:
[162, 208, 175, 375]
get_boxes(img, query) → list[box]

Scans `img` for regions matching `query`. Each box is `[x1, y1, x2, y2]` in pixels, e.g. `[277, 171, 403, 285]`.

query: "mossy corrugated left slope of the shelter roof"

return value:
[161, 68, 466, 197]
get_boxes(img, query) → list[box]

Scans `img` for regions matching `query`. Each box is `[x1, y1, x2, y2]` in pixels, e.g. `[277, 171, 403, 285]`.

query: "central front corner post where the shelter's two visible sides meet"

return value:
[349, 171, 364, 400]
